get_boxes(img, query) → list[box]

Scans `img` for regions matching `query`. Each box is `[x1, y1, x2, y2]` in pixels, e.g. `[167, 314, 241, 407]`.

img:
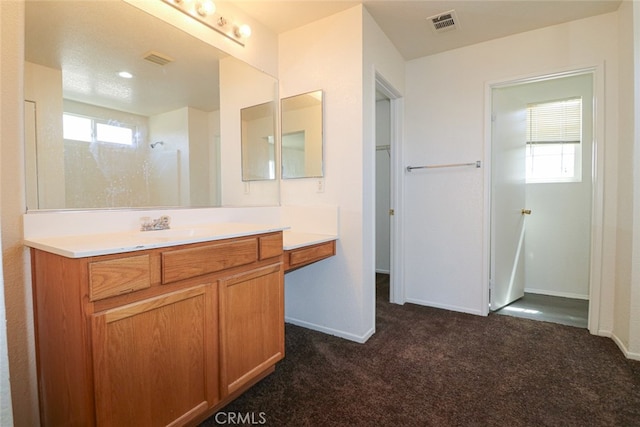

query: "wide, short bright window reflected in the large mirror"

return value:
[62, 113, 136, 145]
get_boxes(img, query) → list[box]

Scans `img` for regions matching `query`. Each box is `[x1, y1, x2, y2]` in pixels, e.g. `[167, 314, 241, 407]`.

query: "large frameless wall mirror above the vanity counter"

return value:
[25, 0, 279, 210]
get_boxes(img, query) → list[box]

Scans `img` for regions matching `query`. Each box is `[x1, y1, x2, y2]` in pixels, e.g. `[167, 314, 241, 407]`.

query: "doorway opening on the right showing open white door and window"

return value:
[489, 72, 595, 328]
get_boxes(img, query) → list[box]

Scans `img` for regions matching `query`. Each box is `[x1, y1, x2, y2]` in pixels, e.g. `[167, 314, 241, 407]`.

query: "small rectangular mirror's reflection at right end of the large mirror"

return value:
[240, 102, 276, 181]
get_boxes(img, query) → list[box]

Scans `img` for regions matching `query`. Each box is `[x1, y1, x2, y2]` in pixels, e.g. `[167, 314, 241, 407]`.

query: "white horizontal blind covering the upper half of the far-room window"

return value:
[527, 98, 582, 144]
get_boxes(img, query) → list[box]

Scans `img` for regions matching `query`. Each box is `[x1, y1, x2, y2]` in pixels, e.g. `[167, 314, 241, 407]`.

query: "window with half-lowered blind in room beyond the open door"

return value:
[526, 98, 582, 183]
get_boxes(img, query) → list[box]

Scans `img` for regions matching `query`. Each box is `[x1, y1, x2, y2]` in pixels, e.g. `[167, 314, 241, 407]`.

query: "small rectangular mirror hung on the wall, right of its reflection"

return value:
[280, 90, 324, 179]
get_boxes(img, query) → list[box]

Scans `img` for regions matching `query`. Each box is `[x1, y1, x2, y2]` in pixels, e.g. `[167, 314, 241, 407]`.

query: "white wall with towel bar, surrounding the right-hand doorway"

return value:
[403, 13, 618, 324]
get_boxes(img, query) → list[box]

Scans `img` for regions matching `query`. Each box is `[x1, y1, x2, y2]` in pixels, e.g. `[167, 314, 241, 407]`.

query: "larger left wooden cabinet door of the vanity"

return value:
[92, 284, 219, 427]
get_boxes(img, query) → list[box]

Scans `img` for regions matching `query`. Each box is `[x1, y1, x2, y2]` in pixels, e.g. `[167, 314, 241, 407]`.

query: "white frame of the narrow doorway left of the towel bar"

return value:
[375, 72, 405, 304]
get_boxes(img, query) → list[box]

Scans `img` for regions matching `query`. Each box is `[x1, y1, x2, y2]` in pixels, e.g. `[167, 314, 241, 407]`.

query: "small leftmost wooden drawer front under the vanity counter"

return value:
[89, 255, 151, 301]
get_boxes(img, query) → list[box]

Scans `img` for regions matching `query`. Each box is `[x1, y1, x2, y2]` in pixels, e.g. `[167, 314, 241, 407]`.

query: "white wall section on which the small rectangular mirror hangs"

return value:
[279, 6, 373, 341]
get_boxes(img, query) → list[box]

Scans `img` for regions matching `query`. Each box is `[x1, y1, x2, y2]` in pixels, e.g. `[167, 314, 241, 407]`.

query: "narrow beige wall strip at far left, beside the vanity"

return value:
[0, 1, 39, 426]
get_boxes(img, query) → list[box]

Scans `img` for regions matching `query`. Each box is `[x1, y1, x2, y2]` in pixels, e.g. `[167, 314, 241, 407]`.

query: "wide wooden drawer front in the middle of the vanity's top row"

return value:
[162, 237, 258, 283]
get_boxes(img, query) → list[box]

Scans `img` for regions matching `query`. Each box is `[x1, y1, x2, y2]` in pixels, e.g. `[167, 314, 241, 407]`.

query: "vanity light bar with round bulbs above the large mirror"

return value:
[162, 0, 251, 47]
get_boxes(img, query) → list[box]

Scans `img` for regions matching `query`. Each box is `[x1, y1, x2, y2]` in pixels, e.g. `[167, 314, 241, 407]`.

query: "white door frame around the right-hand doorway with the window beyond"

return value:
[482, 63, 605, 334]
